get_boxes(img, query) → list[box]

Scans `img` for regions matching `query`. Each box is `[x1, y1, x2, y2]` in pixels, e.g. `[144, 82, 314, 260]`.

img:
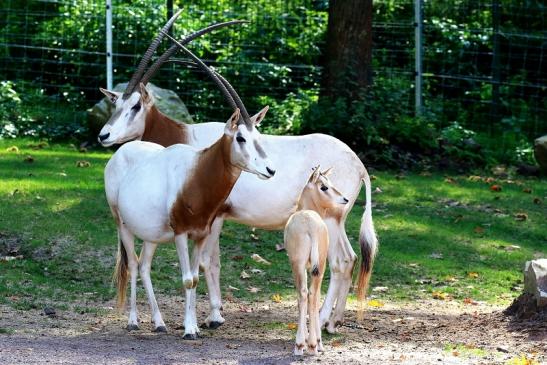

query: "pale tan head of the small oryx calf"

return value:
[300, 166, 348, 210]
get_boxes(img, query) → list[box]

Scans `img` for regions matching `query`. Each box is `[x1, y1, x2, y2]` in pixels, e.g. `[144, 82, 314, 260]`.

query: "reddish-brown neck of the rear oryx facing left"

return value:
[141, 105, 188, 147]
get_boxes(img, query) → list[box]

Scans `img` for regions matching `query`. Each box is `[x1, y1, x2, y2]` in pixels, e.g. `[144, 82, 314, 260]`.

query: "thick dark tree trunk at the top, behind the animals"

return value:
[321, 0, 372, 100]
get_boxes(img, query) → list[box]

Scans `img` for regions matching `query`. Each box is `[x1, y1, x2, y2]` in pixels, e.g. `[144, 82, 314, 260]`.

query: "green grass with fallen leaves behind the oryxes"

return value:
[0, 140, 547, 310]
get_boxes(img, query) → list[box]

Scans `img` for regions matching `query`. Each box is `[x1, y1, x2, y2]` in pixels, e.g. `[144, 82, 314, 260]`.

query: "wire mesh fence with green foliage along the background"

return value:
[0, 0, 547, 141]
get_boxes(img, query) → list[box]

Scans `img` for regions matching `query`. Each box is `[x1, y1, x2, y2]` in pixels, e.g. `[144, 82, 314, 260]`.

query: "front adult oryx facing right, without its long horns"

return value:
[105, 101, 274, 339]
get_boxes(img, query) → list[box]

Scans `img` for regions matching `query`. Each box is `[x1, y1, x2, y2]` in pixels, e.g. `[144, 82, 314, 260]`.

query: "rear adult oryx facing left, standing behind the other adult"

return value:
[99, 15, 377, 332]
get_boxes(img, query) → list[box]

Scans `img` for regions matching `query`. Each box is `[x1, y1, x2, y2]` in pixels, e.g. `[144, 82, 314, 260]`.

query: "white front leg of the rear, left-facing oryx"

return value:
[201, 218, 225, 329]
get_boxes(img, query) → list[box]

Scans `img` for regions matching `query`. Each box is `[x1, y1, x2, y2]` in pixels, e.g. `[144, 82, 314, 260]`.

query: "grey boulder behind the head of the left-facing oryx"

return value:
[87, 83, 193, 141]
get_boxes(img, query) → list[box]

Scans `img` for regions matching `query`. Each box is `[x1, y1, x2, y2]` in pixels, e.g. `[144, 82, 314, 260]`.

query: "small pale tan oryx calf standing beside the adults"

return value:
[285, 166, 348, 355]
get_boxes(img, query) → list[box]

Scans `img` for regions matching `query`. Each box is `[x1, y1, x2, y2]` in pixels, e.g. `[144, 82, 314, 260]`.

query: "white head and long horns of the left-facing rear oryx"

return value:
[98, 10, 244, 147]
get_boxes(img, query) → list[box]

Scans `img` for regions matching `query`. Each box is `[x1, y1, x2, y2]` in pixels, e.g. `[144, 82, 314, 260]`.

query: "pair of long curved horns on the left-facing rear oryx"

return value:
[123, 9, 247, 99]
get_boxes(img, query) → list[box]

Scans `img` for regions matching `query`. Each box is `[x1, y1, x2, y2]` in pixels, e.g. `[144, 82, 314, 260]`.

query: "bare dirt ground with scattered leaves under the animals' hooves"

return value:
[0, 298, 547, 364]
